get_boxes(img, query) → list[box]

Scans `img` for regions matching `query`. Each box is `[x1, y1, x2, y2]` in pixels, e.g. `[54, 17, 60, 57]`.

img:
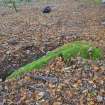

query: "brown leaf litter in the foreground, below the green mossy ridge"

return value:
[0, 57, 105, 105]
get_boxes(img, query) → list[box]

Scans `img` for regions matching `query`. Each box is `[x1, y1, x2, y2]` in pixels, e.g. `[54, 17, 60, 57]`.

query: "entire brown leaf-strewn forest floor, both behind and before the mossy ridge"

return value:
[0, 0, 105, 105]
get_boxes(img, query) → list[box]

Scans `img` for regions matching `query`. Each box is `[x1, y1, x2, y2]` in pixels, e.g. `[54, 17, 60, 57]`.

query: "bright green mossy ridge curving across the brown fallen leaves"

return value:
[7, 41, 103, 79]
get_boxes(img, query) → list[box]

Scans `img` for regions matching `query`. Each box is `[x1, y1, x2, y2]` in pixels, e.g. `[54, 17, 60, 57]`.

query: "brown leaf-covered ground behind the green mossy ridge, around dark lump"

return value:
[0, 0, 105, 78]
